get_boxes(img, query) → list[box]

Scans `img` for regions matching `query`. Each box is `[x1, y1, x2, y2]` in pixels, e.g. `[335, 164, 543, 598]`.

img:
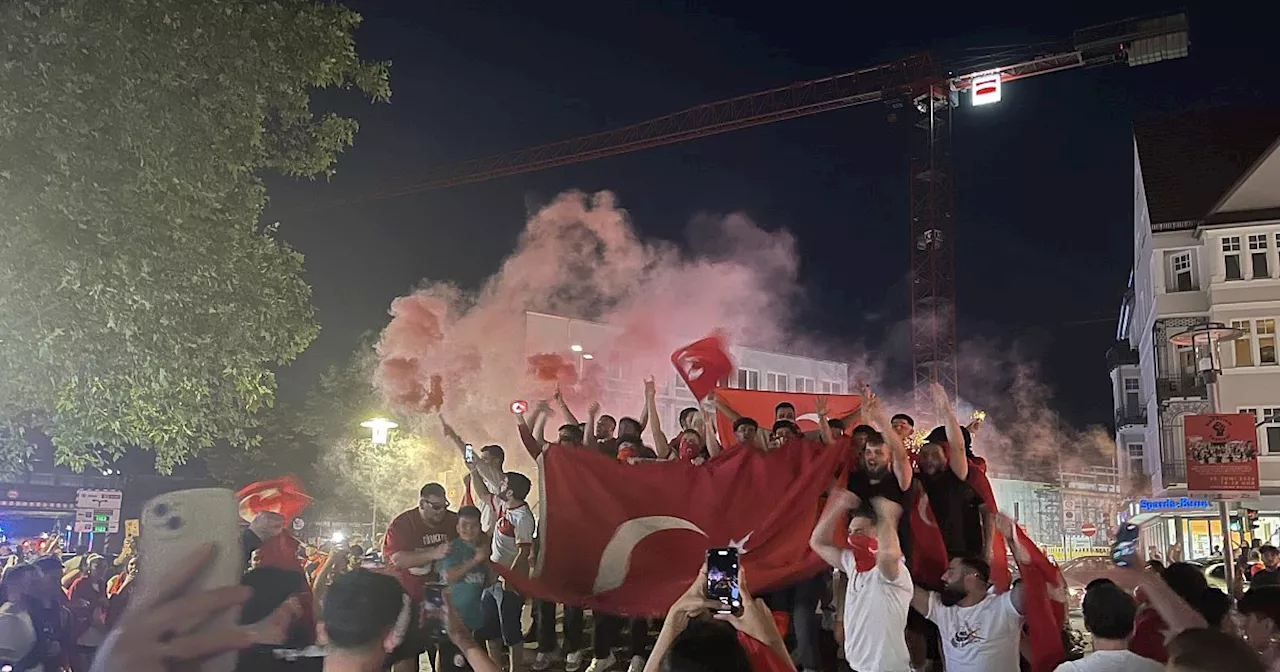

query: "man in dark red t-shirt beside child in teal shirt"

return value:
[383, 483, 458, 672]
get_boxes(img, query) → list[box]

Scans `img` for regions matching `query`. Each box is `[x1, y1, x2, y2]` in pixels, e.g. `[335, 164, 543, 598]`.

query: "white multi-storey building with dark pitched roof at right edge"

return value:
[1107, 109, 1280, 557]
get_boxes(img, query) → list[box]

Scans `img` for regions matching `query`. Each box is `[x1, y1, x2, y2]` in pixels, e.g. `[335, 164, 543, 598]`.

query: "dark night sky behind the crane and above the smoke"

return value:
[259, 0, 1276, 424]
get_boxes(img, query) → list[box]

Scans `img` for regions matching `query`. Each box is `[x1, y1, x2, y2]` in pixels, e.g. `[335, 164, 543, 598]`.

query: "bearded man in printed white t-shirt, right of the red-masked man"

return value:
[911, 558, 1023, 672]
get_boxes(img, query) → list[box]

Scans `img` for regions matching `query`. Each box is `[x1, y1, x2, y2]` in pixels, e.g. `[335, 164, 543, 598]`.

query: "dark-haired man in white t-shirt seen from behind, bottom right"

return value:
[1053, 579, 1165, 672]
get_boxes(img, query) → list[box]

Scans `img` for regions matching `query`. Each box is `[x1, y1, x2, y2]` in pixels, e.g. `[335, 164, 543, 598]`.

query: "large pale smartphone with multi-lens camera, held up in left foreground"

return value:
[134, 488, 246, 672]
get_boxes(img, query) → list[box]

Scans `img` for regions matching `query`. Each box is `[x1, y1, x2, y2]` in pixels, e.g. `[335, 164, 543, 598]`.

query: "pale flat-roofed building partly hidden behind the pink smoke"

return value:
[525, 312, 849, 434]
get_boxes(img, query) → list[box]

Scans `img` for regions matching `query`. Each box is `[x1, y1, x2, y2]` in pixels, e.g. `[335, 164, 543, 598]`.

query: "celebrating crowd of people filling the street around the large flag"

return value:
[0, 381, 1280, 672]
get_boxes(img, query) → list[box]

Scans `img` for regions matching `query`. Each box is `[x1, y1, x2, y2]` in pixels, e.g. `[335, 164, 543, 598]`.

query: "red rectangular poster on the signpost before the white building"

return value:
[1183, 413, 1258, 499]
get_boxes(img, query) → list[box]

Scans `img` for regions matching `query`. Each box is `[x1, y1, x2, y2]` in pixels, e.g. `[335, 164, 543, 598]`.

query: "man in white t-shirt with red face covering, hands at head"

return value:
[809, 488, 913, 672]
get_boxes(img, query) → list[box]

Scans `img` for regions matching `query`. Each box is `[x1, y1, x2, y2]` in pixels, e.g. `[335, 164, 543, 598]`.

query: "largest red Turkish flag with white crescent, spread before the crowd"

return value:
[503, 437, 847, 617]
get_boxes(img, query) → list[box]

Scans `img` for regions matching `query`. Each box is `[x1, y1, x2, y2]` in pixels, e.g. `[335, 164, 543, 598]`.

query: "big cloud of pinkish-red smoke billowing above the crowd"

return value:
[376, 192, 800, 471]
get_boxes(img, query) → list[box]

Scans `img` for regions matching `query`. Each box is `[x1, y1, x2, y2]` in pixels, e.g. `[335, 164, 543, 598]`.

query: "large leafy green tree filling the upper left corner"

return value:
[0, 0, 390, 472]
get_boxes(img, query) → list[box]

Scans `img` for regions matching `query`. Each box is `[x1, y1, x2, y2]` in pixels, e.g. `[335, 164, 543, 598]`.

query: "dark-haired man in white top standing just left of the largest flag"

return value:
[471, 471, 538, 672]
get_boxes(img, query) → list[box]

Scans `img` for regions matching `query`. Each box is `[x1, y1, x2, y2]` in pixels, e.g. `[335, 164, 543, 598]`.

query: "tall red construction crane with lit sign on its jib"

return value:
[358, 14, 1189, 426]
